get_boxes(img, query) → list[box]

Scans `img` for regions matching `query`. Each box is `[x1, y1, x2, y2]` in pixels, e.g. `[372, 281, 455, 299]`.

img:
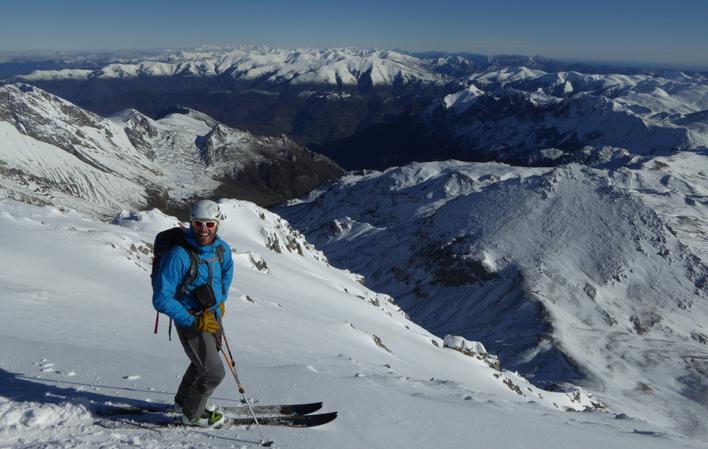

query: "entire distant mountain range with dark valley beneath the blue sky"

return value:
[6, 47, 708, 169]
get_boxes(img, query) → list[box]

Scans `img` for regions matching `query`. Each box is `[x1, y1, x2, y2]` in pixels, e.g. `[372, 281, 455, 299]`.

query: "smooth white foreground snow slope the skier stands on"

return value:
[0, 200, 702, 448]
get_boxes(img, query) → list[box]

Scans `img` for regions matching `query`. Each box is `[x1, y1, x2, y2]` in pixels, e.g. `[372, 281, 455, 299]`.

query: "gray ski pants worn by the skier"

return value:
[175, 326, 226, 419]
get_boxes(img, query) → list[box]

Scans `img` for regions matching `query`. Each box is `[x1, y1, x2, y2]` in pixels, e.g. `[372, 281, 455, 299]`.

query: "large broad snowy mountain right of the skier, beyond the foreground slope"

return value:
[278, 152, 708, 435]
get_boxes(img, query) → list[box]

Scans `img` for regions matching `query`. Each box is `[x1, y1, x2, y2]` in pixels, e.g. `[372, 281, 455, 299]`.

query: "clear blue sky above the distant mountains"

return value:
[0, 0, 708, 69]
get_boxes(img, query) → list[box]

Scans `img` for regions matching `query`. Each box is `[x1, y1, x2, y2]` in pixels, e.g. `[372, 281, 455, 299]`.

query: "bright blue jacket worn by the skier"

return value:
[152, 229, 234, 327]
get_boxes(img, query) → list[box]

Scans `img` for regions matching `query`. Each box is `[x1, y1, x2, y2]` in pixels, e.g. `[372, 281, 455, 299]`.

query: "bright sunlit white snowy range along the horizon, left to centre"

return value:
[19, 46, 445, 86]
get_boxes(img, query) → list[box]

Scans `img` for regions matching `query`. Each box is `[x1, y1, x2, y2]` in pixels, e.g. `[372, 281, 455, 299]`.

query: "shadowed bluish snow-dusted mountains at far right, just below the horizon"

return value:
[429, 67, 708, 165]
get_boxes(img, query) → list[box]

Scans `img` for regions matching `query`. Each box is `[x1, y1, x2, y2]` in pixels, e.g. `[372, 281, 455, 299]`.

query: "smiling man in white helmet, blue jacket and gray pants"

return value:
[152, 200, 233, 427]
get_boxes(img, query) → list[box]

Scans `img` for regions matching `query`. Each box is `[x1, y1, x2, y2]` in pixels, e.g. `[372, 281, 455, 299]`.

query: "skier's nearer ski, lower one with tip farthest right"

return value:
[95, 412, 337, 430]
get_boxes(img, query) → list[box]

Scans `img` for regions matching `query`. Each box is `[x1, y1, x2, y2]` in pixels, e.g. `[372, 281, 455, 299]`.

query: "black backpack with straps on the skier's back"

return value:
[150, 227, 224, 340]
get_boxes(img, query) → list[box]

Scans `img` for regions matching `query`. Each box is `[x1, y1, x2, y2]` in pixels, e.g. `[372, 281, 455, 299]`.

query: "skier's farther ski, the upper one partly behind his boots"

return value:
[94, 402, 322, 417]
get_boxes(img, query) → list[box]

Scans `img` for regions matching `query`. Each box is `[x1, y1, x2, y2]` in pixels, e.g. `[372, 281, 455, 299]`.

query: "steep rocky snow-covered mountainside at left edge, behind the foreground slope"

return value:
[0, 84, 161, 213]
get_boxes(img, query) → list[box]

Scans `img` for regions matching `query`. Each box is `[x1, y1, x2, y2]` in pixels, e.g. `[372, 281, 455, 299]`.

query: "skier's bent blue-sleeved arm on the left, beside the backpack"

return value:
[152, 247, 194, 327]
